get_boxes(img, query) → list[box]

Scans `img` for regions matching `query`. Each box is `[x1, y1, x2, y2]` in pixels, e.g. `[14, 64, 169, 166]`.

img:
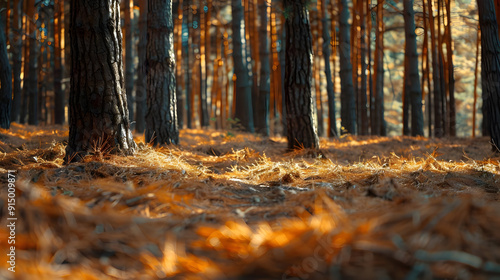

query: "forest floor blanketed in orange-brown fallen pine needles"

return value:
[0, 124, 500, 279]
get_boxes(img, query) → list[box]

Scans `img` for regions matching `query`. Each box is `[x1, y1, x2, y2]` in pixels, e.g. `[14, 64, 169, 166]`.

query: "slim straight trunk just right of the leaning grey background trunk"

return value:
[255, 0, 271, 136]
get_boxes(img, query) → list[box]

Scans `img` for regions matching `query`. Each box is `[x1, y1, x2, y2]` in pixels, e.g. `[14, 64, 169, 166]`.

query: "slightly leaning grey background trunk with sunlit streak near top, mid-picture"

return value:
[231, 0, 254, 132]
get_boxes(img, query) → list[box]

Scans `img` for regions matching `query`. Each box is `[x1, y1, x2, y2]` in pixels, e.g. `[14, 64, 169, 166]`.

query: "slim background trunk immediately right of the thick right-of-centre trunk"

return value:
[321, 0, 338, 137]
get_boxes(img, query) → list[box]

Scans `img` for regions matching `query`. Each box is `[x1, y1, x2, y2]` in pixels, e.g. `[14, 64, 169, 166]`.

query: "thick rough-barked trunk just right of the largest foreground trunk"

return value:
[146, 0, 179, 145]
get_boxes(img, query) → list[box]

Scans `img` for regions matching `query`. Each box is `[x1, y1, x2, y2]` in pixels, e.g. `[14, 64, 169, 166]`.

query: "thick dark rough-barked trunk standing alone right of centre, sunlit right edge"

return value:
[283, 0, 319, 150]
